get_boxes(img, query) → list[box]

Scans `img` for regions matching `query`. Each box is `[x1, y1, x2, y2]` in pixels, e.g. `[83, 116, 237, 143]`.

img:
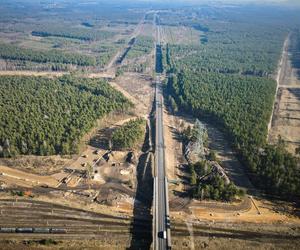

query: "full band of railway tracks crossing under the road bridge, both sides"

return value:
[0, 199, 300, 246]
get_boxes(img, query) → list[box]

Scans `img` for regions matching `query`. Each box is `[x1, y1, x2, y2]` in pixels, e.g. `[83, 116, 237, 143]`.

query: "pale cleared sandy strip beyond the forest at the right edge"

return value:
[268, 32, 300, 153]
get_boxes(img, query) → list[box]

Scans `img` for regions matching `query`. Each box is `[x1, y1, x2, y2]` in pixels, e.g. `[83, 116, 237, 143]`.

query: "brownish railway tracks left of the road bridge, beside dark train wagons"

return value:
[0, 200, 151, 239]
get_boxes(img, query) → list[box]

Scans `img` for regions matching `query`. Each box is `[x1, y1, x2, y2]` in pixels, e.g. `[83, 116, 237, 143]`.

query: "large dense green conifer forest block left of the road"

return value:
[0, 76, 131, 157]
